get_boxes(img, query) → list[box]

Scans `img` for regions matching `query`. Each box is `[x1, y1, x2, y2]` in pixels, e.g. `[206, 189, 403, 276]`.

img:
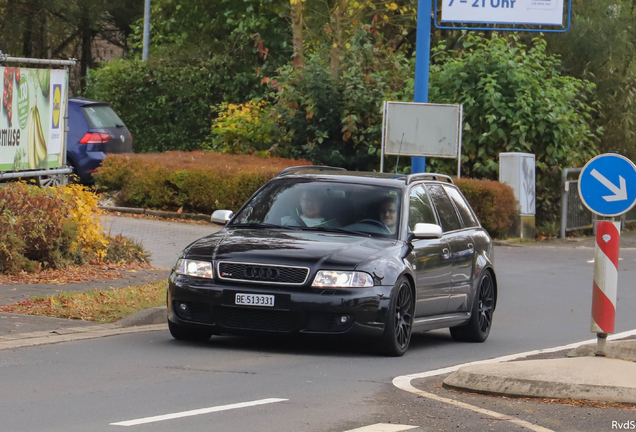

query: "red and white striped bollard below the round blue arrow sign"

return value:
[591, 221, 621, 356]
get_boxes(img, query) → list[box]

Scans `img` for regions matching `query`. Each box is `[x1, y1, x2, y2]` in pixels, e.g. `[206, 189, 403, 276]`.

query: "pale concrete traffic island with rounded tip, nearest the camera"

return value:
[443, 357, 636, 403]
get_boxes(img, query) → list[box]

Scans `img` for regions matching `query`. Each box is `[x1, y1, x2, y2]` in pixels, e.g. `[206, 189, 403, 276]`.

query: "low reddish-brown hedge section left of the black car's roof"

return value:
[95, 151, 309, 213]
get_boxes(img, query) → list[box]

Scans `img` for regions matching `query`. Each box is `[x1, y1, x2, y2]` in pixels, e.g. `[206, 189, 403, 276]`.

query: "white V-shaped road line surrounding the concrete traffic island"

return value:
[393, 329, 636, 432]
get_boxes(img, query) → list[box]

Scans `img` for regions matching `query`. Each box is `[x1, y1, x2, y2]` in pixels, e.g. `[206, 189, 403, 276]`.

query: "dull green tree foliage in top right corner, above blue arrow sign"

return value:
[546, 0, 636, 159]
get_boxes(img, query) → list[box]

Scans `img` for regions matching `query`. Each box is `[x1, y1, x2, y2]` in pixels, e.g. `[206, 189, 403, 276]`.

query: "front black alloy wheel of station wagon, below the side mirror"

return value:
[382, 277, 415, 357]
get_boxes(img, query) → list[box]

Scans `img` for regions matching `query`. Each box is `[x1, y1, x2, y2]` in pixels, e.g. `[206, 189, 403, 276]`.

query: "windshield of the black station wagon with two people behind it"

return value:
[230, 179, 401, 238]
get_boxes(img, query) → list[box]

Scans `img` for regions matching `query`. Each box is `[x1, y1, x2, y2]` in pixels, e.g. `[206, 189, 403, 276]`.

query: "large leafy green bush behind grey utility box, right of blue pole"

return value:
[429, 34, 602, 220]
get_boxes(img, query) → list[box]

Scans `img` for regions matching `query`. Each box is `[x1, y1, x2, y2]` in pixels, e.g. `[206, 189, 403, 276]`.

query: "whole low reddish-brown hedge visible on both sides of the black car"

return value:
[95, 151, 517, 237]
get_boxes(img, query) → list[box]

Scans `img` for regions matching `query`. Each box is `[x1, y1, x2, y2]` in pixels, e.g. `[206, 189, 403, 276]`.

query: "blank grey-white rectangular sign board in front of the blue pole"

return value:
[383, 102, 462, 159]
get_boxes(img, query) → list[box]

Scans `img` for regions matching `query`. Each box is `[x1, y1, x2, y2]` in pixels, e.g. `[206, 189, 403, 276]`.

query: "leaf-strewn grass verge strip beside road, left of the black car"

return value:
[0, 281, 167, 323]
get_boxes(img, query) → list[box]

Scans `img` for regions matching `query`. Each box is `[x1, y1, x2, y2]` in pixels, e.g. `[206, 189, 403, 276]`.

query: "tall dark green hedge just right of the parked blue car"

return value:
[85, 56, 262, 153]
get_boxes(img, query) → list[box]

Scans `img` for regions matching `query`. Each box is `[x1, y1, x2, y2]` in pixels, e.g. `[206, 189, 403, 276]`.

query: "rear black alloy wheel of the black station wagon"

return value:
[450, 270, 495, 342]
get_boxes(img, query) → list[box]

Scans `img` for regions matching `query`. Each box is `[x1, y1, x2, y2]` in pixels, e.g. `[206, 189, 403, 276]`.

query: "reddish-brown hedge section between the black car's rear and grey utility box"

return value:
[455, 179, 518, 237]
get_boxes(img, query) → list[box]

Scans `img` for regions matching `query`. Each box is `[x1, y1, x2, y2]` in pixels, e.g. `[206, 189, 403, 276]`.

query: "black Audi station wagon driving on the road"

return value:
[168, 166, 497, 355]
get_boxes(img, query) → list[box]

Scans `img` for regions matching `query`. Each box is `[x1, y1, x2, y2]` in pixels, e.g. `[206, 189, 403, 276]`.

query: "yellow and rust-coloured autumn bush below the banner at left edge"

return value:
[0, 183, 147, 273]
